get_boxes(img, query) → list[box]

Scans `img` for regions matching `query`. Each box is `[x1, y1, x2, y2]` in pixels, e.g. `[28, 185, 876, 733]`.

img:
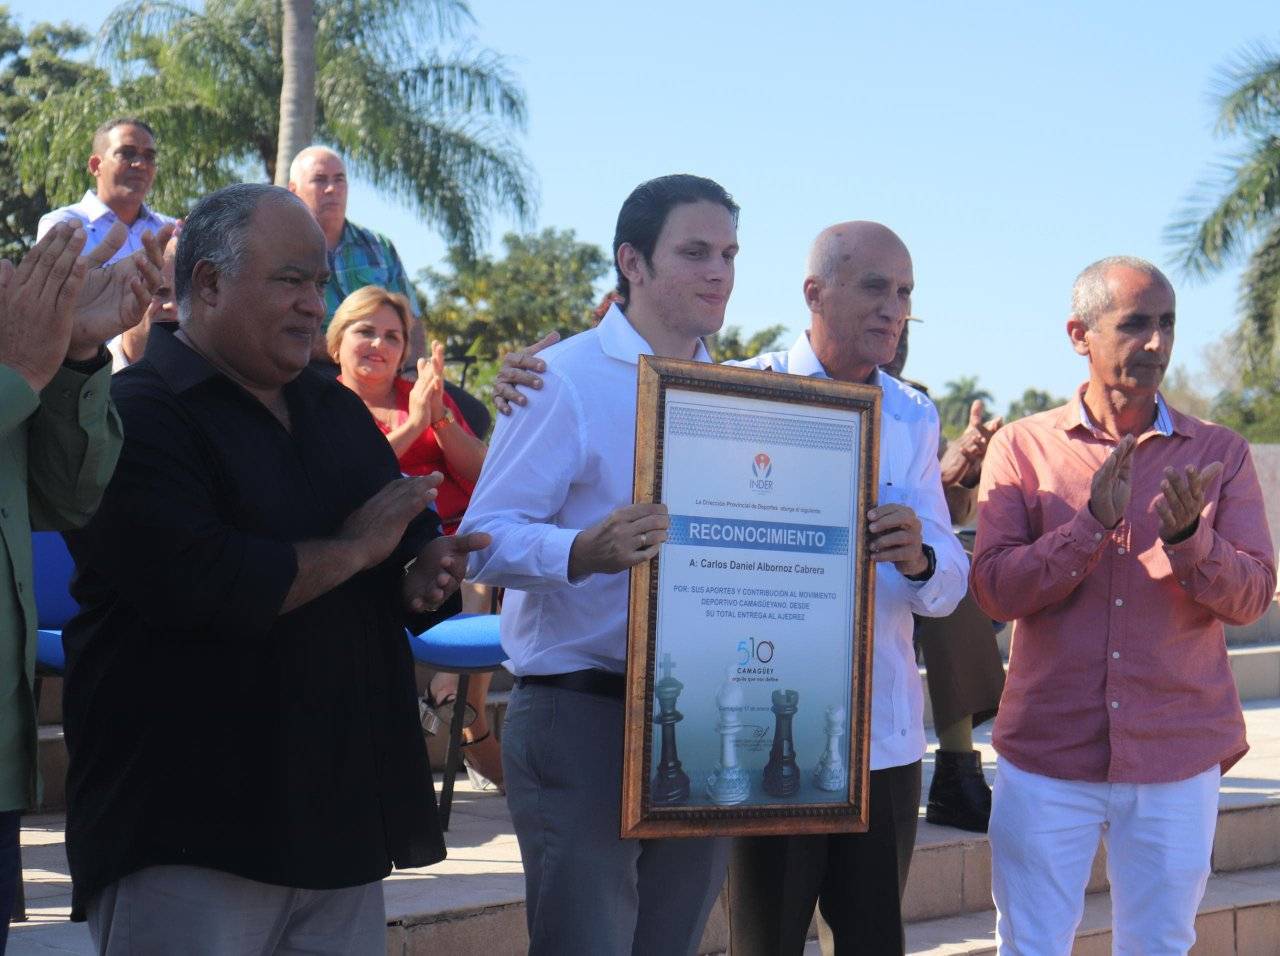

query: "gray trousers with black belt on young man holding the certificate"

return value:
[502, 685, 728, 956]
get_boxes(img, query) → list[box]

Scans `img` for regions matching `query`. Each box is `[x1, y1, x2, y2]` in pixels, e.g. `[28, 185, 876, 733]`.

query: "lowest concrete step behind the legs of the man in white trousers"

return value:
[906, 866, 1280, 956]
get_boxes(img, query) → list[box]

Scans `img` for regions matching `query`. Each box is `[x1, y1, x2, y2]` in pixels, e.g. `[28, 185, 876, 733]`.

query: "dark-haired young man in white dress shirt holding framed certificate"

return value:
[458, 175, 737, 956]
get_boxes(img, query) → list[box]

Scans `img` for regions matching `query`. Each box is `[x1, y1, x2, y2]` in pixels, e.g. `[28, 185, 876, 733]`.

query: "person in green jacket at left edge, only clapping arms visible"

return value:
[0, 218, 173, 955]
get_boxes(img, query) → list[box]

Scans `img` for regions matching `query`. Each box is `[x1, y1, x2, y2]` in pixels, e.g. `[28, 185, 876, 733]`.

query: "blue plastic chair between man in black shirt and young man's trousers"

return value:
[408, 614, 507, 829]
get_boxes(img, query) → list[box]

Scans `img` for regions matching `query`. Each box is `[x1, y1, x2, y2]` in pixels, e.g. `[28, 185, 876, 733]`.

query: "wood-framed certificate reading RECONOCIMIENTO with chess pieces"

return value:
[622, 356, 881, 837]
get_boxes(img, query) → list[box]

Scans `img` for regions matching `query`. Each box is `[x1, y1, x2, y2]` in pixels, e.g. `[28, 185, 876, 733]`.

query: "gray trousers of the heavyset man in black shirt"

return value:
[86, 866, 387, 956]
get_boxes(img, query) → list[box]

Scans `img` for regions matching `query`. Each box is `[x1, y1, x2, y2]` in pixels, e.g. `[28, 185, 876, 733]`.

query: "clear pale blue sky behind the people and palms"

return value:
[13, 0, 1280, 410]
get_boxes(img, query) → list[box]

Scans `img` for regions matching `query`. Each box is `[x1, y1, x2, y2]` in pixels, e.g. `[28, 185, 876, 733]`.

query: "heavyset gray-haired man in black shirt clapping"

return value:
[65, 184, 488, 953]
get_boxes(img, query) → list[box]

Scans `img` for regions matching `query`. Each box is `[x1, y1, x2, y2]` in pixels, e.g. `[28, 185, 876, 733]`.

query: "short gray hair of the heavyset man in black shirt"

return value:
[173, 183, 302, 313]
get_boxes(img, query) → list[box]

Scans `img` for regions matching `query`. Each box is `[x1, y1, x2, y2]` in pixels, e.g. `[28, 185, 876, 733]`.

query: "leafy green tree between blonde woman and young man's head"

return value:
[417, 229, 609, 394]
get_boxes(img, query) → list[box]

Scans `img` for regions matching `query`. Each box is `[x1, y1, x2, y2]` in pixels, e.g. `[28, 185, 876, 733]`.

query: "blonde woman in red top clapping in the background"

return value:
[326, 285, 502, 786]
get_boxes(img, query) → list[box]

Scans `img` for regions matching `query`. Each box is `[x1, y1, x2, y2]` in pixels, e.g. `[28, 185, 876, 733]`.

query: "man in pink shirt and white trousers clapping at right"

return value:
[972, 256, 1276, 955]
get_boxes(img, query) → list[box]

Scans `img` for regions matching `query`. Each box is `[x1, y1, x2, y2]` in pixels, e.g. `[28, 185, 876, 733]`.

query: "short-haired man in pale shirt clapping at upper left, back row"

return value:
[36, 116, 174, 262]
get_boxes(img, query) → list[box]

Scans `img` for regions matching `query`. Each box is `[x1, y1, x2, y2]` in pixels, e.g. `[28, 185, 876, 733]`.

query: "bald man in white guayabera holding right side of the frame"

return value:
[494, 221, 969, 956]
